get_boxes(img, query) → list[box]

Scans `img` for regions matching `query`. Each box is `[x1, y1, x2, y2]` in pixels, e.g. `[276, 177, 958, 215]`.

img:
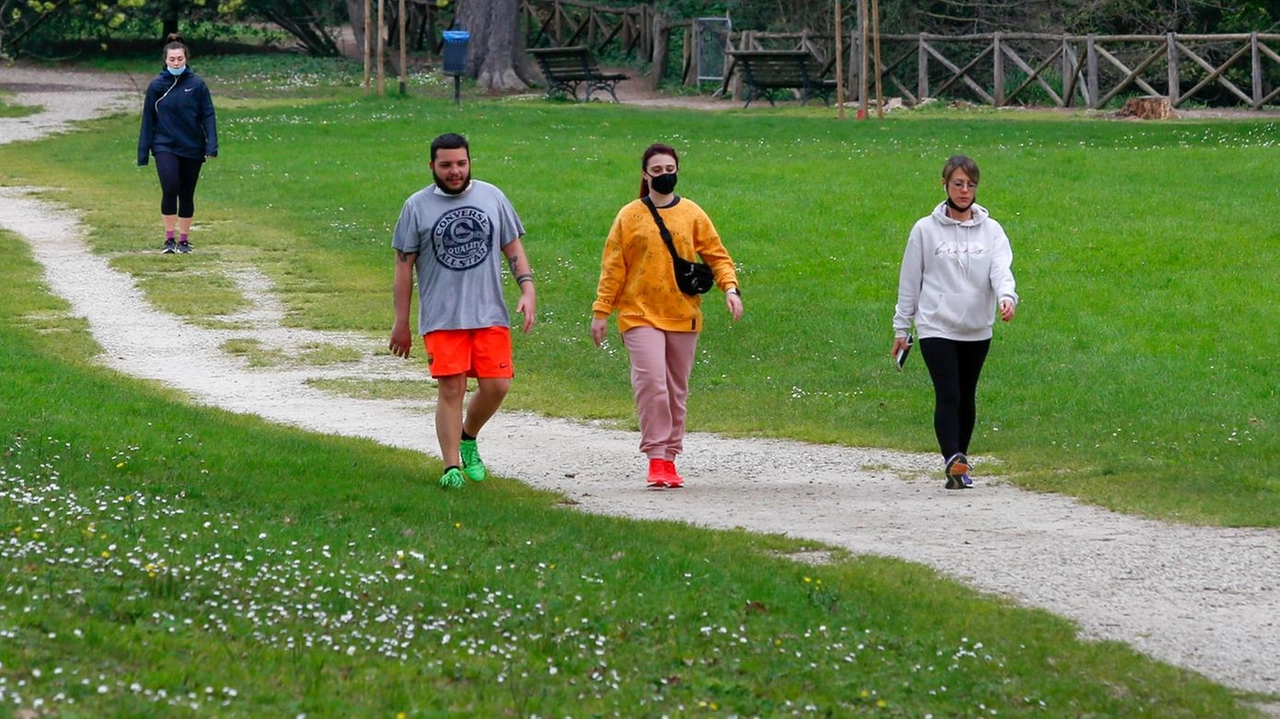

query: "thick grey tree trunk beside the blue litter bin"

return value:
[457, 0, 530, 91]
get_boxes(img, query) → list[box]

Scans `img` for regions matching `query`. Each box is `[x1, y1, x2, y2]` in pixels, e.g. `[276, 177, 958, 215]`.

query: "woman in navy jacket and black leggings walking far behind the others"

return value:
[138, 35, 218, 255]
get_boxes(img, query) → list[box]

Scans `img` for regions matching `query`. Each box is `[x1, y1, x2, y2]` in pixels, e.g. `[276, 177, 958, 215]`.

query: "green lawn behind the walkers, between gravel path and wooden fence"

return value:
[0, 59, 1280, 526]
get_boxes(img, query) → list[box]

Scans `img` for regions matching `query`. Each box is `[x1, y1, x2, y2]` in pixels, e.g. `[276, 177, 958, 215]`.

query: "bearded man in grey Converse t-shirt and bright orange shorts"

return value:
[390, 133, 536, 489]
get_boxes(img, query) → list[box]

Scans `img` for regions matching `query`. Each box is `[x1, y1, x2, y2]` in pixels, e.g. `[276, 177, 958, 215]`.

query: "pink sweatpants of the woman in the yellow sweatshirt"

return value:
[622, 328, 698, 459]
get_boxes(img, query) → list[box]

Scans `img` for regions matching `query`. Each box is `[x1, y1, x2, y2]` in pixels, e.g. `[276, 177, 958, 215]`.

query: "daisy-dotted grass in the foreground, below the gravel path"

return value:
[0, 221, 1257, 719]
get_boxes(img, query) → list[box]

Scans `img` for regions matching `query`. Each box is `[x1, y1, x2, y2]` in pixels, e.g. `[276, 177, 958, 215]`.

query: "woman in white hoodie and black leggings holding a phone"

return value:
[892, 155, 1018, 489]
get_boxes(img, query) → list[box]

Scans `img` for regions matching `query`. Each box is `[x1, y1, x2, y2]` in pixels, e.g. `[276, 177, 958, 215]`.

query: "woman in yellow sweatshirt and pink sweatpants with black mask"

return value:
[591, 143, 742, 489]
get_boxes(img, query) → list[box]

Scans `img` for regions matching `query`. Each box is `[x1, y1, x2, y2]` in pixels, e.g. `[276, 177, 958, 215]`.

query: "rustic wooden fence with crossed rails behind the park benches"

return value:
[521, 0, 1280, 109]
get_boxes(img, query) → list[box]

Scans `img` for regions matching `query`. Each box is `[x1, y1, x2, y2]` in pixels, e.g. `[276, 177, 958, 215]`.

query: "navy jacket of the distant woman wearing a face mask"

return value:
[138, 67, 218, 165]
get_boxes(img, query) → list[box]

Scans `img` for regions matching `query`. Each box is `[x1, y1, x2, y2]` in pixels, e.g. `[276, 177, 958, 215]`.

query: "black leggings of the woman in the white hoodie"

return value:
[920, 338, 991, 459]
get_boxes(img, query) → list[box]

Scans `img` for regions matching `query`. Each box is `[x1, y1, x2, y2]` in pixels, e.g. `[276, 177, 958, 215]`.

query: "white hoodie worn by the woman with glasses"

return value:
[893, 197, 1018, 342]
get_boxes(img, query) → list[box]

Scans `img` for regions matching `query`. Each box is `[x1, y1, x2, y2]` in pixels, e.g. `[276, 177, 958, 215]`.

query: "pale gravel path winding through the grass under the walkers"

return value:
[0, 68, 1280, 701]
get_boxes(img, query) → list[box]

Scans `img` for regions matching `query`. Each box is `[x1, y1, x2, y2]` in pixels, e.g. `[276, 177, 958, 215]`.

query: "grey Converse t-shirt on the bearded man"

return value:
[392, 180, 525, 334]
